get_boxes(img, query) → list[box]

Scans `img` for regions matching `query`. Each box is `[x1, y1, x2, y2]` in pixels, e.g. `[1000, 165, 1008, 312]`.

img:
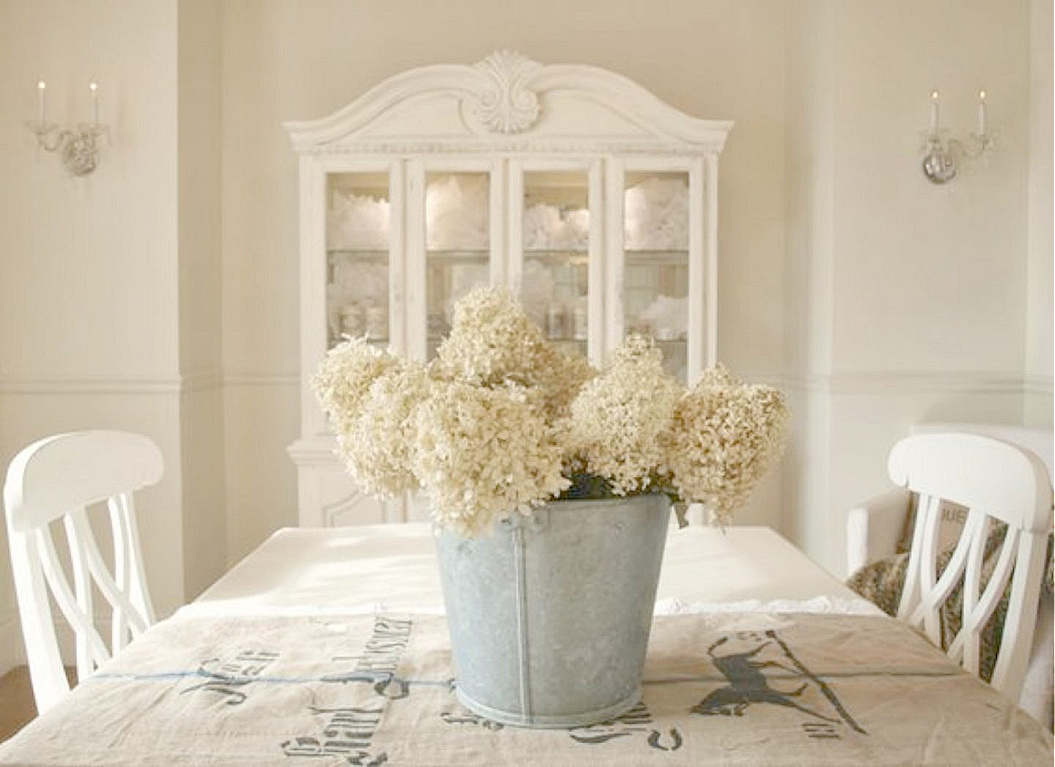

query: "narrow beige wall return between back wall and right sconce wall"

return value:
[782, 0, 837, 556]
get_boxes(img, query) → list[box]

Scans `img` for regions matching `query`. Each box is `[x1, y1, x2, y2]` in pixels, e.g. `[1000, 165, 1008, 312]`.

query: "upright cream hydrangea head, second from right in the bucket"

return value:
[564, 335, 684, 495]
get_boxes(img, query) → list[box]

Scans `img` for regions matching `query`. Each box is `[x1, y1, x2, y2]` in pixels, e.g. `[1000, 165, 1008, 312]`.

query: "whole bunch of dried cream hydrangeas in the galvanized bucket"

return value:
[312, 288, 788, 535]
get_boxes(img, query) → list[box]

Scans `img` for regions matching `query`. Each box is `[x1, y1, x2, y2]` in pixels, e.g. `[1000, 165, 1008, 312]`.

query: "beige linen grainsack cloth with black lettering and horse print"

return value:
[0, 613, 1052, 767]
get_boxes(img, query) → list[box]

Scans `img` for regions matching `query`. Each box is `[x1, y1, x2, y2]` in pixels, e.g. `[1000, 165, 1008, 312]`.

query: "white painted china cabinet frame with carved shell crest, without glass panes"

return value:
[285, 52, 732, 525]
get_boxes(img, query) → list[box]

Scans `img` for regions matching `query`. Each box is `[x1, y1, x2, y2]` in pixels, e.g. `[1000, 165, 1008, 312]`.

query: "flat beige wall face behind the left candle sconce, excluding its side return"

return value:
[0, 0, 184, 668]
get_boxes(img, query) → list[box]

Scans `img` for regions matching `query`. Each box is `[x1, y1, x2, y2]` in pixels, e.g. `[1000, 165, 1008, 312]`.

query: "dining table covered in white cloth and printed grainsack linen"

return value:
[0, 523, 1053, 767]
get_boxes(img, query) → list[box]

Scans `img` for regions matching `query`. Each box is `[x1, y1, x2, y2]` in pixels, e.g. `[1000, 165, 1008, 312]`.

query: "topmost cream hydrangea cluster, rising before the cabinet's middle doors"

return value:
[431, 287, 595, 419]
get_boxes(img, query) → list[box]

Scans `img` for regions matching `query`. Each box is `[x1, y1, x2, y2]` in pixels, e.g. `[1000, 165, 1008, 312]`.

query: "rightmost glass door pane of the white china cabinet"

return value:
[622, 172, 689, 380]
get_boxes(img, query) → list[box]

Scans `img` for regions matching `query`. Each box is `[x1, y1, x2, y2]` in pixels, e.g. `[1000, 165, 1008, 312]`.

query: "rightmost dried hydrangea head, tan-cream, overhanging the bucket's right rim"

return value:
[663, 365, 788, 524]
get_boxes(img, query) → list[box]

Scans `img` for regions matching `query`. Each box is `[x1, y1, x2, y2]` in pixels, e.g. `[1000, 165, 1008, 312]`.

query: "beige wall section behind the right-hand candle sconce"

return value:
[807, 0, 1038, 573]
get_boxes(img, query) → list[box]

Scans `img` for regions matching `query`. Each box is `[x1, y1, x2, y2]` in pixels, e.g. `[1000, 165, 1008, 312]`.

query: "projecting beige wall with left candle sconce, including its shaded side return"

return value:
[0, 0, 226, 670]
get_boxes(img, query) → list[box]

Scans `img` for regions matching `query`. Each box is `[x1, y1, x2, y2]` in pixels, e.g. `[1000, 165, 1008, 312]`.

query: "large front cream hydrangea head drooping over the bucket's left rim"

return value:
[414, 381, 570, 536]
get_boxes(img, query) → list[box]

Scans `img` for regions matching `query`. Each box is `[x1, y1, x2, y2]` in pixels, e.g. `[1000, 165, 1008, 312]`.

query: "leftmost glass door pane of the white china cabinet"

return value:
[326, 173, 389, 346]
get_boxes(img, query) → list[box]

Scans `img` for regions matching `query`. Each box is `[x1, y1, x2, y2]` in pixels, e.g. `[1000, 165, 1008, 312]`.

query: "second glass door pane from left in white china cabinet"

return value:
[425, 173, 491, 360]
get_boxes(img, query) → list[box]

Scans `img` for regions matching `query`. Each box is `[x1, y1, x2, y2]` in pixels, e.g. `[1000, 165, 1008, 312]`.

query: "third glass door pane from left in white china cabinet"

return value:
[520, 171, 590, 356]
